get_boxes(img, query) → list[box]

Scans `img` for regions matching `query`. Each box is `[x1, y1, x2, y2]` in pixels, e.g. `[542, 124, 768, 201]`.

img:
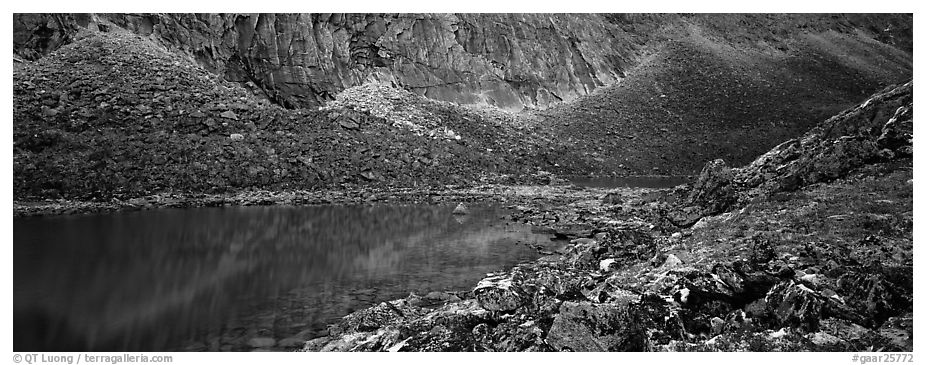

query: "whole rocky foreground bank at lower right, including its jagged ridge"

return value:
[305, 83, 913, 352]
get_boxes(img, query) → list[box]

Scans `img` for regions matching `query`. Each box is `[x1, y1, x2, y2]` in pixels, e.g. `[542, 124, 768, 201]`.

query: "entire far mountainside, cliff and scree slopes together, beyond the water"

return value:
[14, 14, 912, 200]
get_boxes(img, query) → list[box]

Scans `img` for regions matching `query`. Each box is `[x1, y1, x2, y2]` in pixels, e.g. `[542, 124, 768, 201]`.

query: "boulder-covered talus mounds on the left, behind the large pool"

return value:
[13, 30, 576, 200]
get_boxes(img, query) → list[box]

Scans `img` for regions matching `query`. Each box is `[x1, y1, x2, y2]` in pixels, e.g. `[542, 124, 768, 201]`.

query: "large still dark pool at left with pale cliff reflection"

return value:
[13, 205, 550, 351]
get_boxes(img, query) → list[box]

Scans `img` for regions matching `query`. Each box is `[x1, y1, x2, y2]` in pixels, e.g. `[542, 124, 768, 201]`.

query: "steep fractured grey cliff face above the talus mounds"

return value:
[59, 14, 634, 110]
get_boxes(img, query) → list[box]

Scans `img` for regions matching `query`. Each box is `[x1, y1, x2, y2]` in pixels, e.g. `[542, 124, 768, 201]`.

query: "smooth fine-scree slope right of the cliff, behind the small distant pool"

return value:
[538, 16, 912, 174]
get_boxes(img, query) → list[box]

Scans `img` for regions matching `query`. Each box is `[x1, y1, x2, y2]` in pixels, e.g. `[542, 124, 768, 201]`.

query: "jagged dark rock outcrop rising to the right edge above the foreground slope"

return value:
[667, 81, 913, 227]
